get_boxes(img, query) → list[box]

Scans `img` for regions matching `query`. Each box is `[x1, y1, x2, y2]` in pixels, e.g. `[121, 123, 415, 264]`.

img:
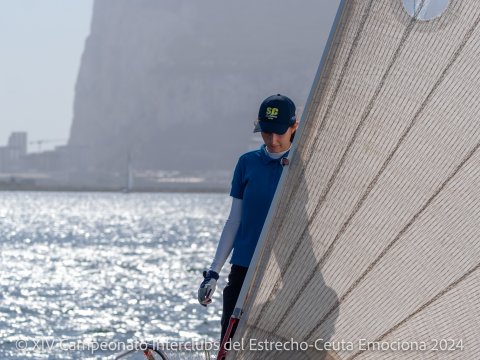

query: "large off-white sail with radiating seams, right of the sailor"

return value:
[231, 0, 480, 360]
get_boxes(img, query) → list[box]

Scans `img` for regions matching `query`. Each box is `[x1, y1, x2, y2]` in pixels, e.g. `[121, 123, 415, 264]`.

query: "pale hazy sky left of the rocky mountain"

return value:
[0, 0, 93, 151]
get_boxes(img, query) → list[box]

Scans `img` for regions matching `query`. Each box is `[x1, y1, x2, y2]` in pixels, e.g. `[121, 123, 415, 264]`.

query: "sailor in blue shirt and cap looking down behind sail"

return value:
[198, 94, 298, 340]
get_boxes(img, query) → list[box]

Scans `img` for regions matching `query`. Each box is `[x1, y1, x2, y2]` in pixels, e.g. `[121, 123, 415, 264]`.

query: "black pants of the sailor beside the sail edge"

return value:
[220, 265, 248, 341]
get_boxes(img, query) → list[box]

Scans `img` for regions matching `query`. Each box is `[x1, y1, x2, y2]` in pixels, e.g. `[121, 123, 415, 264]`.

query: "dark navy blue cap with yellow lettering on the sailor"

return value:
[253, 94, 295, 135]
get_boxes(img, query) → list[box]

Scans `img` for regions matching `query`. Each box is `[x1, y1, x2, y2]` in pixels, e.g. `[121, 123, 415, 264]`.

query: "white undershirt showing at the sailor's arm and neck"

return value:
[209, 146, 290, 273]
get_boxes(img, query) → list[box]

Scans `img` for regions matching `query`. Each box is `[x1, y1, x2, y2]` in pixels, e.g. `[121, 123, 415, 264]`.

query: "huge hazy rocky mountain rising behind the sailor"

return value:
[69, 0, 336, 171]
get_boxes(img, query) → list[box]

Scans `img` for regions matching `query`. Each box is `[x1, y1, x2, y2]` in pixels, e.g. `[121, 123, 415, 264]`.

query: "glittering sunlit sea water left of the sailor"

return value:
[0, 192, 230, 359]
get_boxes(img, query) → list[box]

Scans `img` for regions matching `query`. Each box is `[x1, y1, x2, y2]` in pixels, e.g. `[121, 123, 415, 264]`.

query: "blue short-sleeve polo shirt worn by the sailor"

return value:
[230, 145, 288, 266]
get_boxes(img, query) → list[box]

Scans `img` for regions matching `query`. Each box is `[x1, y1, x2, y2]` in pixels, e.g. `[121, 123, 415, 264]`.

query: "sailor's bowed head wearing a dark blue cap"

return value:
[254, 94, 298, 153]
